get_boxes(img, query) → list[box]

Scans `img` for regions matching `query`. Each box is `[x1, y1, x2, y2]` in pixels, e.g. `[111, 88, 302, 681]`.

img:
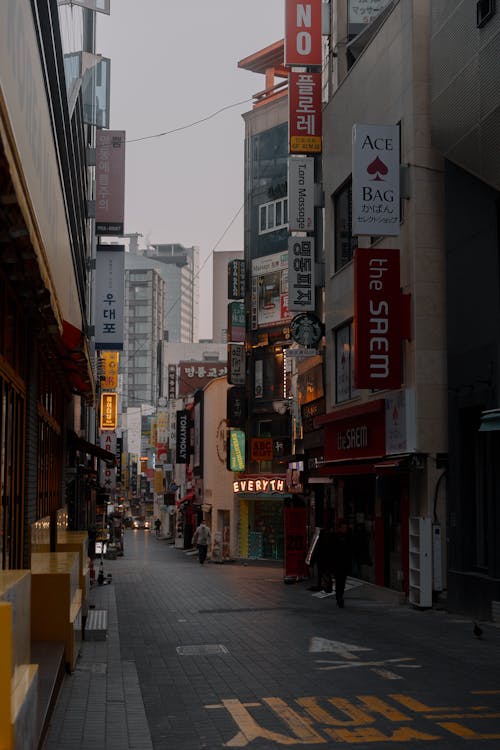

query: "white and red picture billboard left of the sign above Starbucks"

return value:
[251, 250, 291, 330]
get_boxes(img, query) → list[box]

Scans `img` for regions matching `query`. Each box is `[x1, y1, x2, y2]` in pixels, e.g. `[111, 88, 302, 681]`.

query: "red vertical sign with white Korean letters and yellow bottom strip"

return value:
[288, 71, 322, 154]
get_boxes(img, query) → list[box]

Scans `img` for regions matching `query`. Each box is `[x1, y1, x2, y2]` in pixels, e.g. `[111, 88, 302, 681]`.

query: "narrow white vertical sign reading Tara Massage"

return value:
[288, 156, 314, 232]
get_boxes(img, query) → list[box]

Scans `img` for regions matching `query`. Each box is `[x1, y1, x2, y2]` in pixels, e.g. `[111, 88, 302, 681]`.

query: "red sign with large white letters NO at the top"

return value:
[285, 0, 322, 67]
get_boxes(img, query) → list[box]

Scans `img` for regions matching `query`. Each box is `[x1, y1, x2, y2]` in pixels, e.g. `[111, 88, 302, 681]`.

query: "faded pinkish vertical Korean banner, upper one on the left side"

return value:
[95, 129, 125, 237]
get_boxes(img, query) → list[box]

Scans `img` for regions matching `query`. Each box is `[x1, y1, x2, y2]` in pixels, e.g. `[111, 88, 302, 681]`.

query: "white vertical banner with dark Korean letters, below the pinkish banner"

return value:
[94, 245, 125, 351]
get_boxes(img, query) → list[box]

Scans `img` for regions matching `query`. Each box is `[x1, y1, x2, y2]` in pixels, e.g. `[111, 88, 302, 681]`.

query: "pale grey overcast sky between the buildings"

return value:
[97, 0, 284, 338]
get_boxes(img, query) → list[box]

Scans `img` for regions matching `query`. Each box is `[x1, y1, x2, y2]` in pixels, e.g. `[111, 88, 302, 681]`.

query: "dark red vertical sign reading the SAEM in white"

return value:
[354, 253, 403, 390]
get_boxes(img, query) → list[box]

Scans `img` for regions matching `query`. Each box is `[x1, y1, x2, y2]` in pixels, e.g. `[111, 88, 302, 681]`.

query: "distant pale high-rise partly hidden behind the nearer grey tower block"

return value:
[144, 243, 200, 344]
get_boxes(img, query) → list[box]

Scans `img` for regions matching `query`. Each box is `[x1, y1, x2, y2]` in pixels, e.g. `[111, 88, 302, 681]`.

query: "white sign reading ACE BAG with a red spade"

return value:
[352, 125, 400, 236]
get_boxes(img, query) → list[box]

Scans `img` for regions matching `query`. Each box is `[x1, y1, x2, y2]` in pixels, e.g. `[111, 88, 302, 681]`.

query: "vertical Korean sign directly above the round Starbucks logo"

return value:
[288, 237, 316, 312]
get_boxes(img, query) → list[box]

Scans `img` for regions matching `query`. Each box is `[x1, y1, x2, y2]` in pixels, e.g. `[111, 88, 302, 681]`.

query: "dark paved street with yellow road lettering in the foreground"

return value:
[45, 530, 500, 750]
